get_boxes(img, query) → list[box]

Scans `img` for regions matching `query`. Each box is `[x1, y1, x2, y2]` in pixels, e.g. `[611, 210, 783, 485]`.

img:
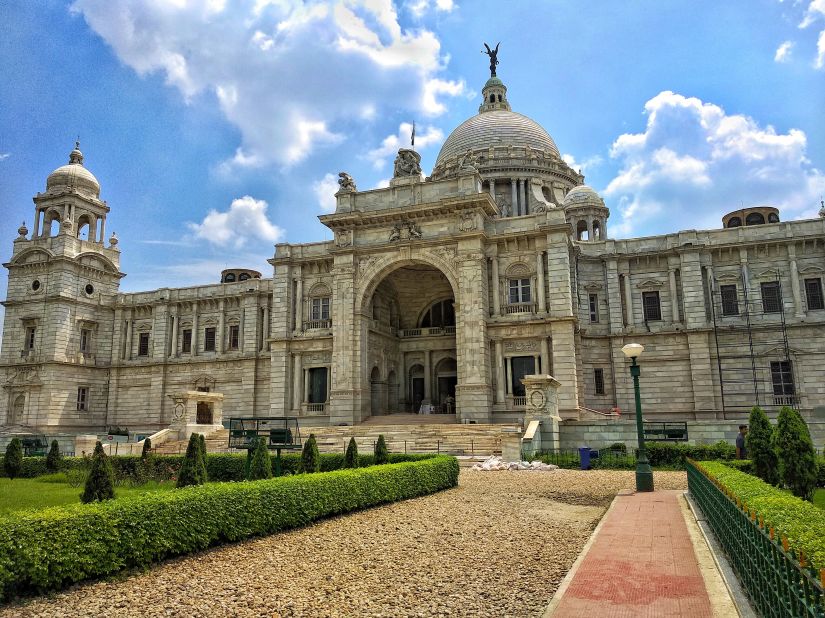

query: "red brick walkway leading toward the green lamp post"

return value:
[552, 491, 713, 618]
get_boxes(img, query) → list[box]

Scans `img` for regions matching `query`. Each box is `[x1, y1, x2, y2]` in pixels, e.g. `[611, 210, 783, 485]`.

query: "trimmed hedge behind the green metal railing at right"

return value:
[694, 461, 825, 569]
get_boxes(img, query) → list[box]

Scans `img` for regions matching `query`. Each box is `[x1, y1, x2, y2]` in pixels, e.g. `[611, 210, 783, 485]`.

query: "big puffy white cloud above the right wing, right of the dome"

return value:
[604, 91, 825, 235]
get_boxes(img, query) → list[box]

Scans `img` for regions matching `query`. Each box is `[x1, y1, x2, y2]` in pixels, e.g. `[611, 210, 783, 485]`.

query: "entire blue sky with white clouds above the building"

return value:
[0, 0, 825, 298]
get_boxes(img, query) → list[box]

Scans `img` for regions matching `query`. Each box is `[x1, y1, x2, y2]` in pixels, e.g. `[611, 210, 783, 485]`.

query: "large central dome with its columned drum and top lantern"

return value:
[430, 76, 584, 217]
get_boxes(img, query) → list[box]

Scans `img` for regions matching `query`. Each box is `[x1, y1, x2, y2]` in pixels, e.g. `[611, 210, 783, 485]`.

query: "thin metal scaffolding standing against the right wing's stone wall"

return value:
[711, 272, 799, 418]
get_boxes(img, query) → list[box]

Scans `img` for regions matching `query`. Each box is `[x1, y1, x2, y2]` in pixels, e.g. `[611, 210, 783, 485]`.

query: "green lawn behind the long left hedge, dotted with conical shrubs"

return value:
[0, 474, 175, 515]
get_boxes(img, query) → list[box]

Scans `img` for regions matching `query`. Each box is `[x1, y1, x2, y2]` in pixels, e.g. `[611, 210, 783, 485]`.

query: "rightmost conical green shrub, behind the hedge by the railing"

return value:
[774, 406, 816, 501]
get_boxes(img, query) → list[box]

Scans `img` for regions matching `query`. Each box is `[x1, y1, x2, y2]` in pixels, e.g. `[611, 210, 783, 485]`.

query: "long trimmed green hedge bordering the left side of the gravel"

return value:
[0, 455, 458, 600]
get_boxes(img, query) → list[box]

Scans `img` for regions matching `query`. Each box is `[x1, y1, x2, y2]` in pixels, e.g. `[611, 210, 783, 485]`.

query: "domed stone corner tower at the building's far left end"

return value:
[0, 143, 124, 430]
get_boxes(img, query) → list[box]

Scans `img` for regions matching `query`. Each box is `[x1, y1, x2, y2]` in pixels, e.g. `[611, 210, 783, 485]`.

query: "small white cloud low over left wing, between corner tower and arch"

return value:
[187, 195, 284, 249]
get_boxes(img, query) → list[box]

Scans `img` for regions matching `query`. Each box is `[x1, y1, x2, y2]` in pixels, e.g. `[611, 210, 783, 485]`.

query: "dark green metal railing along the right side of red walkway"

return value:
[686, 461, 825, 618]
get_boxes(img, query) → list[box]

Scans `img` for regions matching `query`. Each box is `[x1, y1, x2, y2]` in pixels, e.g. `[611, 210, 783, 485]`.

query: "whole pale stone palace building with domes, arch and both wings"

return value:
[0, 77, 825, 432]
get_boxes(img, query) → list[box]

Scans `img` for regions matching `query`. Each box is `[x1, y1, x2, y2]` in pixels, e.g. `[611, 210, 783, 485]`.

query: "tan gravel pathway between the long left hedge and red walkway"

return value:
[0, 470, 686, 618]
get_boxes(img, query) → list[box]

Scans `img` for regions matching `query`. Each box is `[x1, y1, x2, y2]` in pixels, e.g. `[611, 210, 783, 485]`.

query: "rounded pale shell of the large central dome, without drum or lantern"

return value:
[435, 109, 561, 167]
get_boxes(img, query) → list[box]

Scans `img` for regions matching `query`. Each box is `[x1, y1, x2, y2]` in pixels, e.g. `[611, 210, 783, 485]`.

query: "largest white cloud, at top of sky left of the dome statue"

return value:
[72, 0, 465, 169]
